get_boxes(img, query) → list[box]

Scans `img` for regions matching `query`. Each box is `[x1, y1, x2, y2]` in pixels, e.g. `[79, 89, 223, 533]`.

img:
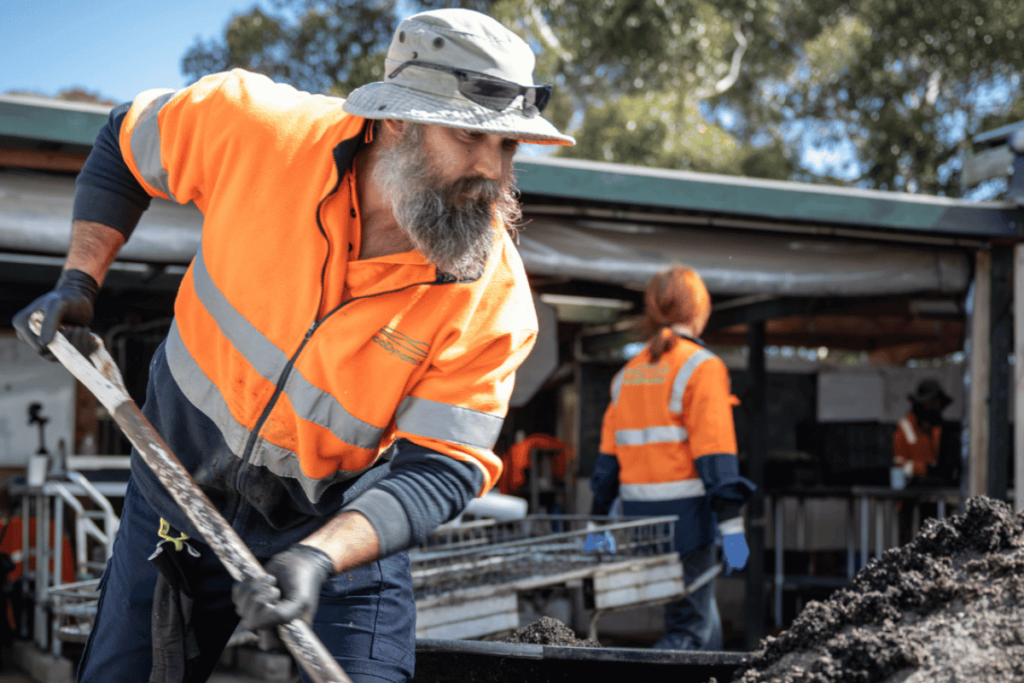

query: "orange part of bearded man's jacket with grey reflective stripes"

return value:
[120, 70, 538, 548]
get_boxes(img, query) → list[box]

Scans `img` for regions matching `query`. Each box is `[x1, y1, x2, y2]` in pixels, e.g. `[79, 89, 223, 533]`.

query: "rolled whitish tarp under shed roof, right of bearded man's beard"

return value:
[519, 219, 971, 296]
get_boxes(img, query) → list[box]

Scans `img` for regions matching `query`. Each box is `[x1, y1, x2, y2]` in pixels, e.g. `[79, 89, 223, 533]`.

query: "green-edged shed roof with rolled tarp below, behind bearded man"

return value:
[0, 95, 1024, 356]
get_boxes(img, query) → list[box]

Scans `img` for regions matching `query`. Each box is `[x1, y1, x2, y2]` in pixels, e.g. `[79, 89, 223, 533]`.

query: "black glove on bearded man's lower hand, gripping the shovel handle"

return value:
[231, 544, 334, 649]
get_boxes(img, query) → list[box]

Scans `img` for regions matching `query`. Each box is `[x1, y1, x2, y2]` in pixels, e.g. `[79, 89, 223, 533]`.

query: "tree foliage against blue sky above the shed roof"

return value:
[182, 0, 1024, 196]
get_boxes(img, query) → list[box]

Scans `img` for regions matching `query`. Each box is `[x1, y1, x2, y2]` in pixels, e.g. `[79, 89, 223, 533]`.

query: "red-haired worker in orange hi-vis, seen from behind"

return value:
[591, 266, 755, 650]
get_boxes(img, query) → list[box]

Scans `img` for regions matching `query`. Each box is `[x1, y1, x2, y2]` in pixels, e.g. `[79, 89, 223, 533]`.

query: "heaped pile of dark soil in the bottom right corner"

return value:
[733, 498, 1024, 683]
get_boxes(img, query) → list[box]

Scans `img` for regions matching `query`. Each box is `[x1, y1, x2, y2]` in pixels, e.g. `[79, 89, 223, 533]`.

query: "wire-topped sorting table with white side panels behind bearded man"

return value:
[410, 515, 688, 639]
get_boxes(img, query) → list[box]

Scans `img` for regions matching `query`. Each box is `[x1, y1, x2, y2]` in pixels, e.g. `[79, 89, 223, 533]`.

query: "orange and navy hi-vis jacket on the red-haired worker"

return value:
[591, 338, 754, 556]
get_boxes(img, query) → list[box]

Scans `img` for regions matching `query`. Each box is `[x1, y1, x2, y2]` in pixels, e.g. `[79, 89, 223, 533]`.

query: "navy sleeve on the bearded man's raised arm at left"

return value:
[72, 102, 152, 239]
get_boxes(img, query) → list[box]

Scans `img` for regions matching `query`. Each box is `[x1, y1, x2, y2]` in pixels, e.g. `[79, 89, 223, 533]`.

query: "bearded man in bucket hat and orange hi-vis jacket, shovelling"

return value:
[15, 9, 573, 683]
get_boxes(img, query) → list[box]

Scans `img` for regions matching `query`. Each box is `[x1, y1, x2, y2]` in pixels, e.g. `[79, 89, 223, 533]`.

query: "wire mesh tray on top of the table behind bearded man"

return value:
[410, 515, 677, 600]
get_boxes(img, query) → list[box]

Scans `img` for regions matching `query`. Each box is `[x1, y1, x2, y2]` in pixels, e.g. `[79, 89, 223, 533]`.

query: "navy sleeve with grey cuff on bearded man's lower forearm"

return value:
[345, 439, 483, 557]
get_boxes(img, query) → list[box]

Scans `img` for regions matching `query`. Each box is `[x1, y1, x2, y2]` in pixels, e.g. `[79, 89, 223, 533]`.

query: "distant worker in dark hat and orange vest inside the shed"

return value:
[893, 379, 953, 478]
